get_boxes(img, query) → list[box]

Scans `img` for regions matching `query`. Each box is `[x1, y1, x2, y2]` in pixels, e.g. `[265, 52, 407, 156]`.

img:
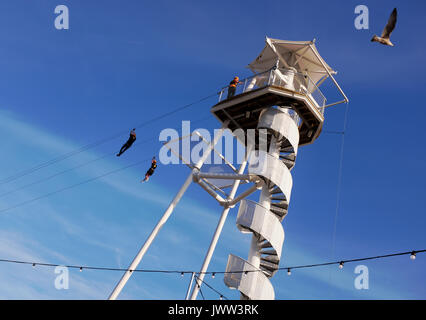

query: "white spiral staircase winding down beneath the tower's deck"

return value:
[224, 107, 300, 300]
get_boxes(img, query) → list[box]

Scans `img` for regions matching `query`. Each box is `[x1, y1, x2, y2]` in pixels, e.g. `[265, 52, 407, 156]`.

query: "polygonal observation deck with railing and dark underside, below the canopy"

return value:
[211, 68, 327, 145]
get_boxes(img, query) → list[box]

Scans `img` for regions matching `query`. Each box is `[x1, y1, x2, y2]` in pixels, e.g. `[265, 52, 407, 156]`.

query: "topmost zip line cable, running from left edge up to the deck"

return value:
[0, 93, 217, 185]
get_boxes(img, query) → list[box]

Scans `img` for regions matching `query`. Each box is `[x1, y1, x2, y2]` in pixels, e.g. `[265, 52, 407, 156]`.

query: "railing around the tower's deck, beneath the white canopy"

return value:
[219, 68, 327, 114]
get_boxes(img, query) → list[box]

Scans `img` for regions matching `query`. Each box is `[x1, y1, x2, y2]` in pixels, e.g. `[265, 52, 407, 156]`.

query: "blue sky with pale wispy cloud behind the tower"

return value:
[0, 0, 426, 299]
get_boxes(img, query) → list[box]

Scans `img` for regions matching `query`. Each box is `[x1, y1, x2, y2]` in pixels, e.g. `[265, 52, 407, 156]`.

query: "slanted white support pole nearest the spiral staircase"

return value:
[191, 143, 254, 300]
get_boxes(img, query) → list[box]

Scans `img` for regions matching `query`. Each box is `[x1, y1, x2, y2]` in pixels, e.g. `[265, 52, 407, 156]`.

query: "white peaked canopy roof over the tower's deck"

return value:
[248, 37, 336, 83]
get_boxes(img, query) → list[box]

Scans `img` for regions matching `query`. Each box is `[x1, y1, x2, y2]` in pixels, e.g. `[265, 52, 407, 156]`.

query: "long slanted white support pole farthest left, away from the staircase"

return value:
[108, 121, 229, 300]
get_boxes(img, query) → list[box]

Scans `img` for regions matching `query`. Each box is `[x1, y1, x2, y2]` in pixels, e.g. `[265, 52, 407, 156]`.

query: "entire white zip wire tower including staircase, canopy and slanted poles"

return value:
[109, 37, 349, 300]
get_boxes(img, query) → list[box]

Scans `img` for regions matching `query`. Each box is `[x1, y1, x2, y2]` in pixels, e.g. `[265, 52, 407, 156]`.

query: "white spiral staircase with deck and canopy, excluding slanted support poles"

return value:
[208, 38, 348, 299]
